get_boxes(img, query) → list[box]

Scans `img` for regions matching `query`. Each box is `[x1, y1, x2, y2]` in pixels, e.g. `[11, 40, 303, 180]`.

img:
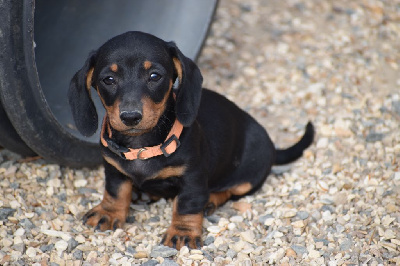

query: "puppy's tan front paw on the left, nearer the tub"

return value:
[82, 204, 127, 231]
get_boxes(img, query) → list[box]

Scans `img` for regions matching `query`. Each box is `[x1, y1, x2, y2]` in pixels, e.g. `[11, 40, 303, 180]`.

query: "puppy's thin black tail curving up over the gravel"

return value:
[275, 122, 315, 165]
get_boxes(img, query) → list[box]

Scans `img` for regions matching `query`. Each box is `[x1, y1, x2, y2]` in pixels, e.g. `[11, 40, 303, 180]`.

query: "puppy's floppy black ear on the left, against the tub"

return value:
[68, 52, 98, 137]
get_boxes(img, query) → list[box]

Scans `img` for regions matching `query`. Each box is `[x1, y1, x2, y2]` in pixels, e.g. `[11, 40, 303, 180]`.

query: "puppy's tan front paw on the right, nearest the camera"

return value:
[161, 226, 203, 250]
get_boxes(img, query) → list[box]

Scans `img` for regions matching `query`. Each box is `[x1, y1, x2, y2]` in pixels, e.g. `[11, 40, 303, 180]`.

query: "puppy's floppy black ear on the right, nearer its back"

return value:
[168, 42, 203, 127]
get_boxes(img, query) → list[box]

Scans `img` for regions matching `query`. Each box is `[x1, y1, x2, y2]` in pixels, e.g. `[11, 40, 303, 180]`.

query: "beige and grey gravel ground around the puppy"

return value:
[0, 0, 400, 265]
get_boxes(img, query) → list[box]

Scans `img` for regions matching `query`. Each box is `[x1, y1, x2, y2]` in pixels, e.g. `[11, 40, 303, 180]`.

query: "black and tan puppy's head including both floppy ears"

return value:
[68, 32, 203, 136]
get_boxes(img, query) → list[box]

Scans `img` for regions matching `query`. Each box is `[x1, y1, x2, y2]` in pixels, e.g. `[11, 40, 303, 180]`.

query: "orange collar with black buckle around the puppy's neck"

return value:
[100, 115, 183, 160]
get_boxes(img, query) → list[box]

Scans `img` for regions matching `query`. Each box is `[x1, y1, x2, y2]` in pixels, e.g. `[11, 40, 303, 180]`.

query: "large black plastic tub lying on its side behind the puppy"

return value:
[0, 0, 217, 167]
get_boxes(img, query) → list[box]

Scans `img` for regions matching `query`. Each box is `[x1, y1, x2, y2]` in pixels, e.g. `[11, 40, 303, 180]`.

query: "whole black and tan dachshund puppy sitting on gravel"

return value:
[68, 32, 314, 249]
